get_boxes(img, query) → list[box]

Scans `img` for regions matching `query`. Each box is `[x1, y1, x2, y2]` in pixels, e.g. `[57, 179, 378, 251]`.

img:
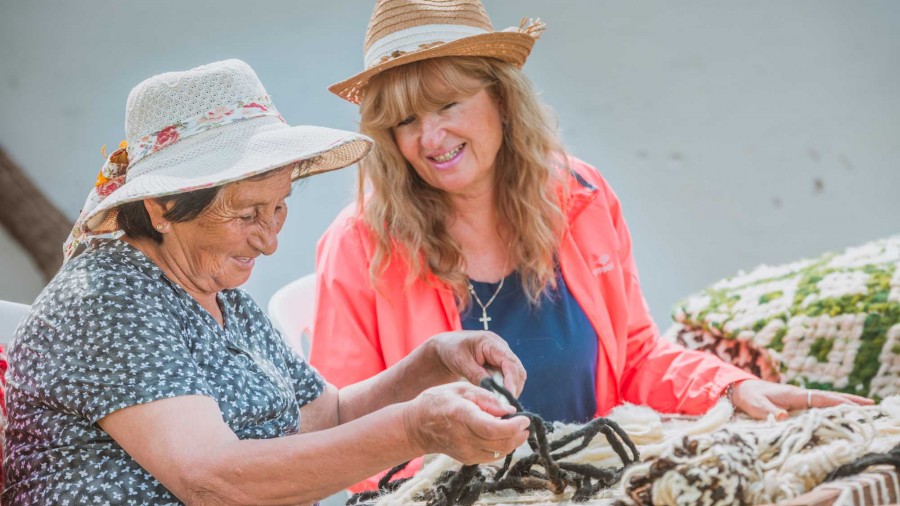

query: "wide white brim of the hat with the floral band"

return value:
[85, 117, 372, 234]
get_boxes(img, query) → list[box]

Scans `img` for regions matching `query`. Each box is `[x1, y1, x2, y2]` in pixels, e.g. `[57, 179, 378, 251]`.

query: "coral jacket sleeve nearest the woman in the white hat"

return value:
[309, 208, 386, 388]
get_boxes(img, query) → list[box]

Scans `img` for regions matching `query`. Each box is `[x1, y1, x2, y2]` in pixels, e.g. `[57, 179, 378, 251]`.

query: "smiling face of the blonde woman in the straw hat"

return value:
[393, 79, 503, 195]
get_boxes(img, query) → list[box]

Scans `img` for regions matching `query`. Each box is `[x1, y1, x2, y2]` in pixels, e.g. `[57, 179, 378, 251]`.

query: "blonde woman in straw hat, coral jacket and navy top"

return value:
[310, 0, 870, 440]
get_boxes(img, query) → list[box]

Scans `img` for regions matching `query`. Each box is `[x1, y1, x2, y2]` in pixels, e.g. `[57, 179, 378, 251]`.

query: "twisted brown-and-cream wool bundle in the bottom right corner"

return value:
[621, 397, 900, 505]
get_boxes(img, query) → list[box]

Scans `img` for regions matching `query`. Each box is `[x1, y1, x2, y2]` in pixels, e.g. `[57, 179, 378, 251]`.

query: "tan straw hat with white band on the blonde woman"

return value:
[328, 0, 544, 104]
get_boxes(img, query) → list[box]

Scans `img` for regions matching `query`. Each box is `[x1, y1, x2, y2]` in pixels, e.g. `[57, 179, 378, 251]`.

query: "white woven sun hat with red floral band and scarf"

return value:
[63, 60, 372, 261]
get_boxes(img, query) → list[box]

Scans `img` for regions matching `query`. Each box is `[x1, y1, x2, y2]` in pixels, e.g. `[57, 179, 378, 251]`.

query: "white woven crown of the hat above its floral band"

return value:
[125, 60, 267, 146]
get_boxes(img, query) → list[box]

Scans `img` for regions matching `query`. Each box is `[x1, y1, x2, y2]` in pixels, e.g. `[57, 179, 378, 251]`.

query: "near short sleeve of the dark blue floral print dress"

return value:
[18, 271, 214, 423]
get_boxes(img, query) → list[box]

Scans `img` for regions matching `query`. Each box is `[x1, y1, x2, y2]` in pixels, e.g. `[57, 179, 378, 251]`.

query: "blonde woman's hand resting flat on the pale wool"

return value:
[732, 380, 874, 420]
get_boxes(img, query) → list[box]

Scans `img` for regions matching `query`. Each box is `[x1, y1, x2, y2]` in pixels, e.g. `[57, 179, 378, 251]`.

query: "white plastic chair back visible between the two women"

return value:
[268, 273, 316, 357]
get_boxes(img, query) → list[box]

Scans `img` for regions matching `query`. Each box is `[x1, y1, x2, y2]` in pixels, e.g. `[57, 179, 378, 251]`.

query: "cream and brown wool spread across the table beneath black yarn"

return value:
[376, 396, 900, 506]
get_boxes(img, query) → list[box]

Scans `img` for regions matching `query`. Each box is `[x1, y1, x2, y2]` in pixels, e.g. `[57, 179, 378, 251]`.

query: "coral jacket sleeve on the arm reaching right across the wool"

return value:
[601, 171, 756, 414]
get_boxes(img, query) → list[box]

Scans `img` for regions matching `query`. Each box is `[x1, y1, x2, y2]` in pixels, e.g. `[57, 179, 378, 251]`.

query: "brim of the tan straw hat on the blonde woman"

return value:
[328, 31, 536, 104]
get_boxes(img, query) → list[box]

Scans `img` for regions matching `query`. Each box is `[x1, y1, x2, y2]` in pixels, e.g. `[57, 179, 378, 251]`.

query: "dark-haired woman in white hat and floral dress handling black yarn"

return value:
[3, 60, 528, 504]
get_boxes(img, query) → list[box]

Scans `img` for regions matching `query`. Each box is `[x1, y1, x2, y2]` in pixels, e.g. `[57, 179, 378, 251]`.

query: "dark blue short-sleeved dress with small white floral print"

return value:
[2, 240, 325, 505]
